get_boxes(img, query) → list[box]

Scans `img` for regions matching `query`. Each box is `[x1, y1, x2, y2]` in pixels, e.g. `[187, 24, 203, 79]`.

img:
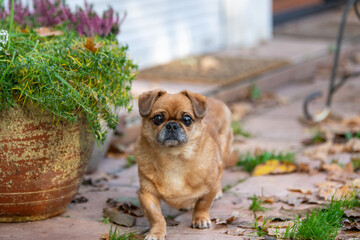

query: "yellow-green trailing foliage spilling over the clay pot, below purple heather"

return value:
[0, 22, 137, 142]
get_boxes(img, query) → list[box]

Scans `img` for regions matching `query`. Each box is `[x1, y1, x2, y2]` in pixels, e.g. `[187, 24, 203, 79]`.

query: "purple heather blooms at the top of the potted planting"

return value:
[0, 0, 126, 36]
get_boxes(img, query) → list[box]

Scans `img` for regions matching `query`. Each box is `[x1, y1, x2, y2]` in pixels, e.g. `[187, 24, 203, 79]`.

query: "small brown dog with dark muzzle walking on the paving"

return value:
[135, 90, 232, 240]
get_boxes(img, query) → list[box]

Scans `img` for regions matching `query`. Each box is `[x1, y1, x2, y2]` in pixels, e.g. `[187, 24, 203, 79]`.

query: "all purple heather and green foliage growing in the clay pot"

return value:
[0, 0, 137, 142]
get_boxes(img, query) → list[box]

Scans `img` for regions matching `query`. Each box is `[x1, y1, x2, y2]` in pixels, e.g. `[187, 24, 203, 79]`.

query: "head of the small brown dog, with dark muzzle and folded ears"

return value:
[139, 90, 206, 147]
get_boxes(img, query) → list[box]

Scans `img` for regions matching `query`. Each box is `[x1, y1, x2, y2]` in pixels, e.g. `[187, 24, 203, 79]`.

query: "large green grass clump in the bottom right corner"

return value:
[285, 193, 359, 240]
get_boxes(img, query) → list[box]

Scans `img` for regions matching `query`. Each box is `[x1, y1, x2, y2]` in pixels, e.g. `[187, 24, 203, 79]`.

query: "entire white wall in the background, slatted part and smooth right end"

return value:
[64, 0, 272, 68]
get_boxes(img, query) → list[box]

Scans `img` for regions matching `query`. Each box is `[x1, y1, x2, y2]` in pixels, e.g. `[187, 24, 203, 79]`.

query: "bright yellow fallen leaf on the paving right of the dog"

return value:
[252, 159, 296, 176]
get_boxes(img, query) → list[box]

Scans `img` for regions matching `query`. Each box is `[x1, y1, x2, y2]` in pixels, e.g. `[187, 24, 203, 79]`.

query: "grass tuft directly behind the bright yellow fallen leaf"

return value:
[236, 151, 295, 172]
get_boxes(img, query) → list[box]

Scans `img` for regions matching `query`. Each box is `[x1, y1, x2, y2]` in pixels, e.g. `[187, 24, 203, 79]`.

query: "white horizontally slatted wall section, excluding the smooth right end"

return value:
[69, 0, 223, 68]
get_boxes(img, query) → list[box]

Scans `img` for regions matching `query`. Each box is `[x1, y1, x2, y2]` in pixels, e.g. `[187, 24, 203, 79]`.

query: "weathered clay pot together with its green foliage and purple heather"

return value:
[0, 0, 136, 222]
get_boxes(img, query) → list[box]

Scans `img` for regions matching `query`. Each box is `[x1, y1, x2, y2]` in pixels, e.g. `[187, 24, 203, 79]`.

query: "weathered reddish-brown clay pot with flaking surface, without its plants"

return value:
[0, 104, 94, 222]
